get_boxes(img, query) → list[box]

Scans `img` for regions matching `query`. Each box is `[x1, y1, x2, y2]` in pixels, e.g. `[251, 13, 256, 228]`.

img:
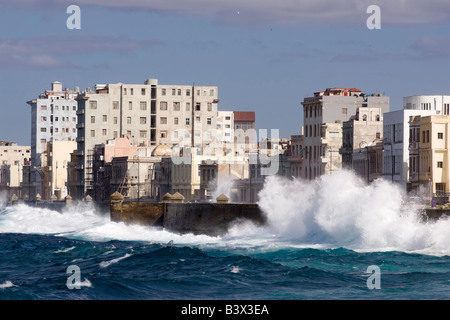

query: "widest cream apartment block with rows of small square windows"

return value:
[77, 79, 220, 198]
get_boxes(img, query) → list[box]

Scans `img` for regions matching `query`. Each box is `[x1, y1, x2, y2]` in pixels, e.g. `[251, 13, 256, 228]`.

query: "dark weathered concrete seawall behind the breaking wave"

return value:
[110, 193, 266, 236]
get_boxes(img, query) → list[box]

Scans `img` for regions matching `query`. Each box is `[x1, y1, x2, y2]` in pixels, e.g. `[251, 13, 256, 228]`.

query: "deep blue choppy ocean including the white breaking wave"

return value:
[0, 171, 450, 302]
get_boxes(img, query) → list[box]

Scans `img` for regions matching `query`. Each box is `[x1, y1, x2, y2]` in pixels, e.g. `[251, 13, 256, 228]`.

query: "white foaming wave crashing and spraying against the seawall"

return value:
[0, 171, 450, 255]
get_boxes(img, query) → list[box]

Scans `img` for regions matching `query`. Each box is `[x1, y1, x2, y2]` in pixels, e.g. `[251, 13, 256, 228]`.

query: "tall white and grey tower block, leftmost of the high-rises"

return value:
[27, 81, 80, 198]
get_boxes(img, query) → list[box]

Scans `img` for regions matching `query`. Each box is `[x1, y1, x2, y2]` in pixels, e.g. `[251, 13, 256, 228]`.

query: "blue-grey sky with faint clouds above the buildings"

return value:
[0, 0, 450, 145]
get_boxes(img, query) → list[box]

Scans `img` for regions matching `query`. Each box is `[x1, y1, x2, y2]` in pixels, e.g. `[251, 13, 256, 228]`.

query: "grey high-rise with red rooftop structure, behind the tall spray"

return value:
[302, 88, 389, 179]
